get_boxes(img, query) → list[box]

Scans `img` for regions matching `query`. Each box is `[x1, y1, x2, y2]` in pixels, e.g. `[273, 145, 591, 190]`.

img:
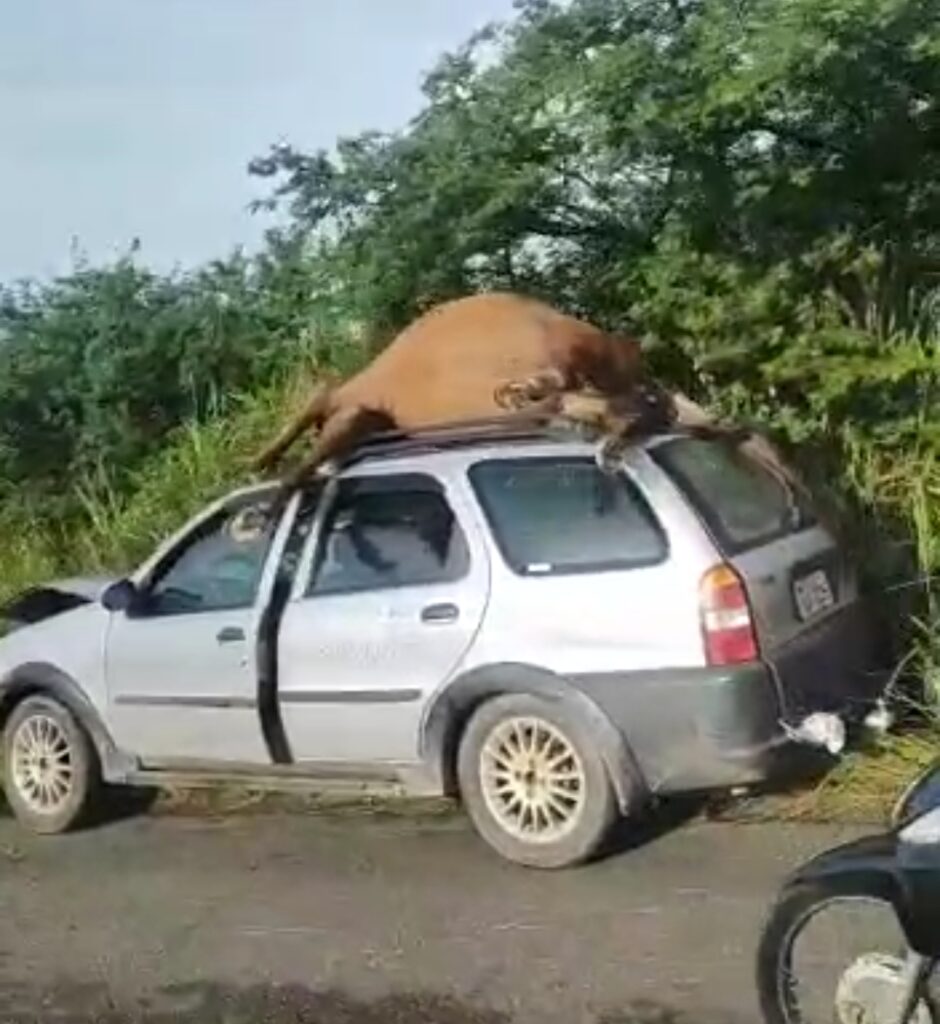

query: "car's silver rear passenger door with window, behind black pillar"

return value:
[279, 473, 489, 763]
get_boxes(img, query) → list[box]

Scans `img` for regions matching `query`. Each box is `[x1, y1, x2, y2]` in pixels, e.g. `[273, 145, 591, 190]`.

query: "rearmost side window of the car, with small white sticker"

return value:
[470, 458, 667, 575]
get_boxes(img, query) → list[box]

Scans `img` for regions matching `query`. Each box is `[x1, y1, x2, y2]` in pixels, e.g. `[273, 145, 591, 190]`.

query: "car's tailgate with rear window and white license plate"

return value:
[651, 437, 881, 715]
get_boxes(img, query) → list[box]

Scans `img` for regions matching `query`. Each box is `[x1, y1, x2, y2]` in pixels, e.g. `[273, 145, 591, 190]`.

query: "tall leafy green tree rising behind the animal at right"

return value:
[252, 0, 940, 393]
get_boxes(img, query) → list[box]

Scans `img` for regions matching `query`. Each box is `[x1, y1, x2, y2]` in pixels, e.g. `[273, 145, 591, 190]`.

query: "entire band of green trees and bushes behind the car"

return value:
[0, 0, 940, 585]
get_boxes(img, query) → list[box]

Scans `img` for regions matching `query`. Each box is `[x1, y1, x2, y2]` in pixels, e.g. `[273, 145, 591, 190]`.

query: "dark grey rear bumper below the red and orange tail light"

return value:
[571, 663, 880, 795]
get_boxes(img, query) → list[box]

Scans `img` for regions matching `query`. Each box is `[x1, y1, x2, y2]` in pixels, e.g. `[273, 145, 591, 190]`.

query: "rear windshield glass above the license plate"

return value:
[650, 437, 813, 554]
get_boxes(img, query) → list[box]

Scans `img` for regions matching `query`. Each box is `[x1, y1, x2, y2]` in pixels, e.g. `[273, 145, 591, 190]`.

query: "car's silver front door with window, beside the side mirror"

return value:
[104, 497, 282, 765]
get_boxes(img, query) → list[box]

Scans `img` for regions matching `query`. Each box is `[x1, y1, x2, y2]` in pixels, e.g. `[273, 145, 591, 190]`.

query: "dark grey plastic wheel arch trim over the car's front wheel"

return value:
[0, 662, 133, 782]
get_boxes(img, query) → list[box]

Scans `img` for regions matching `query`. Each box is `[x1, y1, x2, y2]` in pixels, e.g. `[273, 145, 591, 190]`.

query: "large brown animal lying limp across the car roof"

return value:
[253, 293, 643, 489]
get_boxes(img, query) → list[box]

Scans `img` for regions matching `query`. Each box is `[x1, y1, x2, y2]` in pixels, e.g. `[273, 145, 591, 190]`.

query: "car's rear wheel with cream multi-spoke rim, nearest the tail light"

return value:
[457, 693, 617, 868]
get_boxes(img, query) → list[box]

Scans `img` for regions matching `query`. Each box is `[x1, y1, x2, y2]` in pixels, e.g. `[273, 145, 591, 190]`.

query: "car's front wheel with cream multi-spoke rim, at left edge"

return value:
[3, 696, 101, 836]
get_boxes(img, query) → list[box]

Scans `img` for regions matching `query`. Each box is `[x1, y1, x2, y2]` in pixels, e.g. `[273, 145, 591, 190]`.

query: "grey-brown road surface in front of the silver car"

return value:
[0, 816, 864, 1024]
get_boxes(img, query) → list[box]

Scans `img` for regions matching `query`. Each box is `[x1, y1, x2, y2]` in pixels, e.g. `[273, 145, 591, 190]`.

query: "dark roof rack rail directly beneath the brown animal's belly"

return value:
[342, 416, 578, 466]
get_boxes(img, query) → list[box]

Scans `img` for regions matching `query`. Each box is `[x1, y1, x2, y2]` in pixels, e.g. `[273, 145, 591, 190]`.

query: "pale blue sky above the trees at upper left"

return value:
[0, 0, 512, 282]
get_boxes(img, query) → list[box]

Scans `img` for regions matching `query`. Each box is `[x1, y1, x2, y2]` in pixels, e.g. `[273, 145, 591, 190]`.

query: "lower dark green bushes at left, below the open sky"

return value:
[0, 237, 350, 511]
